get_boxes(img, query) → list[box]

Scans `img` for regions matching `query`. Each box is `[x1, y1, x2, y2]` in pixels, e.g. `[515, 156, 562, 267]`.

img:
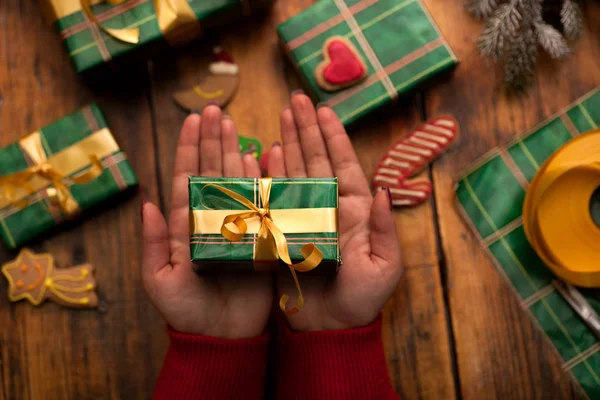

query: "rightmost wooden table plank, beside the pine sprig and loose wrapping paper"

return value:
[424, 0, 600, 400]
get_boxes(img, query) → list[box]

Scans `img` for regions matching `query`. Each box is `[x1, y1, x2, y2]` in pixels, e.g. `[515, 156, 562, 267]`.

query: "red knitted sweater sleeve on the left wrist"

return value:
[154, 329, 269, 400]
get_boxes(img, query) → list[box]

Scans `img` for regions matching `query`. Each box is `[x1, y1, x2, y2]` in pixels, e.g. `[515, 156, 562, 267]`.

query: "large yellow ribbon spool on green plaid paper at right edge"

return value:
[523, 130, 600, 287]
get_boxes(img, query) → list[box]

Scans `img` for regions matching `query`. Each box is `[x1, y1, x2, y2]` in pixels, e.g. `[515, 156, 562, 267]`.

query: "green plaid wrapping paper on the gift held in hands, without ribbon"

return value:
[189, 176, 341, 272]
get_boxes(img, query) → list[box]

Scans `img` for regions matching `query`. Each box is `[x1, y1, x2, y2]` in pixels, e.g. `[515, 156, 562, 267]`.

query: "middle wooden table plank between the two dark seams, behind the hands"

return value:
[152, 0, 455, 399]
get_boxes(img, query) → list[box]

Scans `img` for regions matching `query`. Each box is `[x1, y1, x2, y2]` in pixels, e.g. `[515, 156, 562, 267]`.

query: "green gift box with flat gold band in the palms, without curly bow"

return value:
[189, 176, 341, 273]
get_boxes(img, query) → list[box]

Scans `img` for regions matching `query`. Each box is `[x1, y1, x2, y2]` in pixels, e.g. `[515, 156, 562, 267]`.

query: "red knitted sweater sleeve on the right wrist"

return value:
[276, 318, 399, 400]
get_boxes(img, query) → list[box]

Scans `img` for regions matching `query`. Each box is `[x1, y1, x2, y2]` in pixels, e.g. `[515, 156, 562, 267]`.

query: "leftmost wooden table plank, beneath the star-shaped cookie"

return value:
[0, 0, 167, 399]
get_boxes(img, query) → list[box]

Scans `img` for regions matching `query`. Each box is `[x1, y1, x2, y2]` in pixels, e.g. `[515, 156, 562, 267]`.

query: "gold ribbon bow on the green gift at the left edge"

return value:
[0, 132, 103, 217]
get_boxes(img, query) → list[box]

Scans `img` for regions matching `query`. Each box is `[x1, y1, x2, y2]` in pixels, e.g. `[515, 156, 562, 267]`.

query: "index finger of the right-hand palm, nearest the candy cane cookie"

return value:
[317, 107, 371, 196]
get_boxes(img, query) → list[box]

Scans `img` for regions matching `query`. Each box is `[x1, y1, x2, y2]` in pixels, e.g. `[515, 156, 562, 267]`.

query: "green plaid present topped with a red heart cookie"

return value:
[277, 0, 458, 125]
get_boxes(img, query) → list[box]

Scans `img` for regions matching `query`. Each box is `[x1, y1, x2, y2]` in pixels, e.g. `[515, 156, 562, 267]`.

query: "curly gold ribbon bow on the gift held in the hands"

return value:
[206, 178, 323, 315]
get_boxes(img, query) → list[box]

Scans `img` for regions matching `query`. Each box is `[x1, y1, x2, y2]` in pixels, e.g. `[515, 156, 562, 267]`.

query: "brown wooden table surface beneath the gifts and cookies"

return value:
[0, 0, 600, 400]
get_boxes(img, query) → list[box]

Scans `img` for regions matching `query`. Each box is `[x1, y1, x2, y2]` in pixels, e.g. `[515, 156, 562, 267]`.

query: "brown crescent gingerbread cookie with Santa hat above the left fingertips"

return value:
[173, 47, 239, 112]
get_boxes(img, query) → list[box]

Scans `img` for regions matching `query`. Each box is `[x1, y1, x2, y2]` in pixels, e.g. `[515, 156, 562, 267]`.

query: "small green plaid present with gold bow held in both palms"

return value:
[189, 177, 341, 310]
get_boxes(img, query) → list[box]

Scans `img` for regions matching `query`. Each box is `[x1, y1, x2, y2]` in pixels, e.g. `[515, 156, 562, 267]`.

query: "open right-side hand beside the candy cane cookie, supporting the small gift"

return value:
[268, 94, 402, 331]
